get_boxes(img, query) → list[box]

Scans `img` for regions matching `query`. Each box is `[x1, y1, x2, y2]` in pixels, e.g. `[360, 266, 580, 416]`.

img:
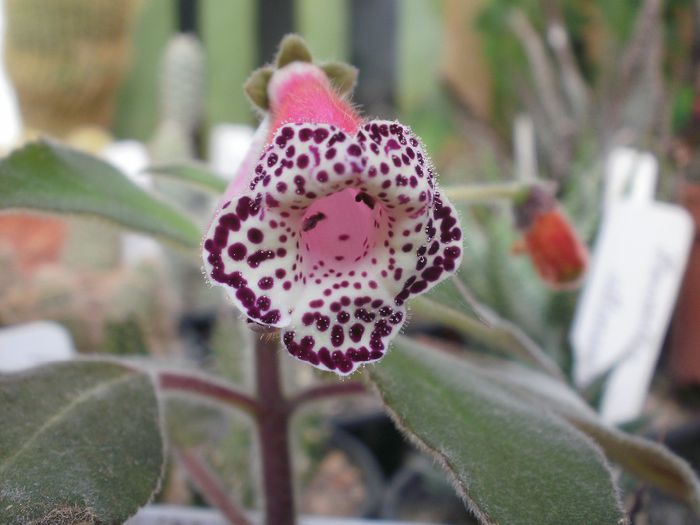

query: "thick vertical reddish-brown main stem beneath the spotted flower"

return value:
[255, 336, 296, 525]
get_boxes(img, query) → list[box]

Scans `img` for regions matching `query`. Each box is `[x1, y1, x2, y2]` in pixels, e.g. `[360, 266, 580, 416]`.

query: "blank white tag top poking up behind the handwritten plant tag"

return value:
[604, 148, 659, 212]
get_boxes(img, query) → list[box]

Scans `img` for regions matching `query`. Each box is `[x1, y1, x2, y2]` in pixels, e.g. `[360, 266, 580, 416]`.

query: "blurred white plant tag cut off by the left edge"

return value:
[0, 321, 76, 374]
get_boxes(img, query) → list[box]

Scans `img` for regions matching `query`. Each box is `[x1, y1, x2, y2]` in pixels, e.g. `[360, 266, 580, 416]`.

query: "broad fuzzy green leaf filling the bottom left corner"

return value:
[0, 361, 164, 525]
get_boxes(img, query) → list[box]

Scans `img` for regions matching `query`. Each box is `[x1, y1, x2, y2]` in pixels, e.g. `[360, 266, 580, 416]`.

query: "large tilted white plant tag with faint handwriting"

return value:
[571, 200, 693, 423]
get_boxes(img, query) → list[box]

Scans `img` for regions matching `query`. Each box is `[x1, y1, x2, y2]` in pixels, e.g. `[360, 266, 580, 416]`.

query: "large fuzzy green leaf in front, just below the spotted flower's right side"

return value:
[370, 338, 625, 525]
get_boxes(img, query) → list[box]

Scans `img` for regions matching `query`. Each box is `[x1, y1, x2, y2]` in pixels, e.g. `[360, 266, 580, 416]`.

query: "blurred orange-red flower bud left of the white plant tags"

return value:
[515, 186, 588, 290]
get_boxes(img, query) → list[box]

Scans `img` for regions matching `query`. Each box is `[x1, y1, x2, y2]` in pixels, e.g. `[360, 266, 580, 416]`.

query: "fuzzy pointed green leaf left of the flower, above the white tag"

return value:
[0, 141, 202, 249]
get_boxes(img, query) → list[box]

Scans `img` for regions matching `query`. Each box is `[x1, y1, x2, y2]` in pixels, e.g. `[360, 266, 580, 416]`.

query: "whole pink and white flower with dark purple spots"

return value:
[204, 39, 462, 375]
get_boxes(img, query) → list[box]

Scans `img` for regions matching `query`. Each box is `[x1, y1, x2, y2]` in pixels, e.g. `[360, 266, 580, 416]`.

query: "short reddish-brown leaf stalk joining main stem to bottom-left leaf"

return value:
[158, 371, 260, 414]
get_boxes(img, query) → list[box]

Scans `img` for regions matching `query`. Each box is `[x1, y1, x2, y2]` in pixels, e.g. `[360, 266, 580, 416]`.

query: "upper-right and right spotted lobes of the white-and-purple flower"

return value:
[363, 121, 462, 305]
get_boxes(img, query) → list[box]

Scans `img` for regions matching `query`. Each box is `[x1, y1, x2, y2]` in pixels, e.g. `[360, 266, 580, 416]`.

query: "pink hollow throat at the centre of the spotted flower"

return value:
[301, 188, 382, 269]
